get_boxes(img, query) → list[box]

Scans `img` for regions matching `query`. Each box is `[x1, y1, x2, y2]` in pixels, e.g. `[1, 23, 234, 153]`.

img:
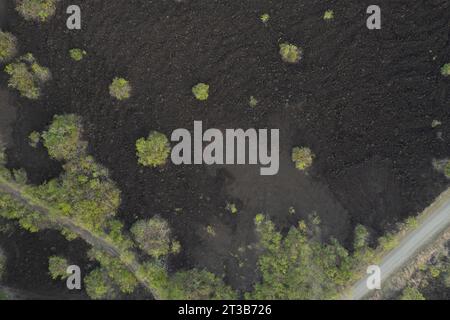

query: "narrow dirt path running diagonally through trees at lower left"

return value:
[0, 177, 159, 300]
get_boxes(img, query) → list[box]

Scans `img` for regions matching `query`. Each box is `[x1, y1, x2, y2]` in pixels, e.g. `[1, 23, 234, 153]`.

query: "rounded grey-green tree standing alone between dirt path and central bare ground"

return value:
[131, 216, 180, 258]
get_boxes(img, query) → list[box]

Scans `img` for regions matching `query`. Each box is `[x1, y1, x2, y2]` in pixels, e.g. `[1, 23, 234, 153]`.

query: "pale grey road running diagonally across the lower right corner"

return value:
[347, 195, 450, 300]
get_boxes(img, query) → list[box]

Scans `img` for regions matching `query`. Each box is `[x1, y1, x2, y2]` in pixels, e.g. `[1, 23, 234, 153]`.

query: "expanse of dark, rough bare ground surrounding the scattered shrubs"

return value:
[0, 0, 450, 296]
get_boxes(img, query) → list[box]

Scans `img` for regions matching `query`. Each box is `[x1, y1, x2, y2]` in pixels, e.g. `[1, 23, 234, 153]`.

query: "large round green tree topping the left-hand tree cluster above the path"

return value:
[42, 114, 84, 160]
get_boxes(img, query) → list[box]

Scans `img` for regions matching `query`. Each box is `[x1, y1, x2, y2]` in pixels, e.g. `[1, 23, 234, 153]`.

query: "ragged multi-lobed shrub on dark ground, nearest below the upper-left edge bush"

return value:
[5, 53, 51, 100]
